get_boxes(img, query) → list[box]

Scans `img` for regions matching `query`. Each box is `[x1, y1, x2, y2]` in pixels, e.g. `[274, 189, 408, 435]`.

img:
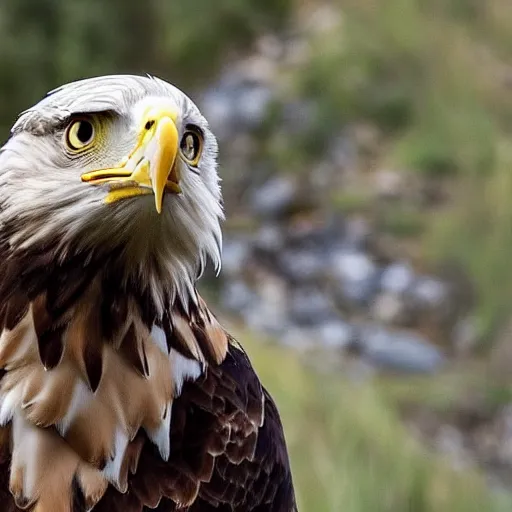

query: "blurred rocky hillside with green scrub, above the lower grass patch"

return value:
[198, 0, 512, 496]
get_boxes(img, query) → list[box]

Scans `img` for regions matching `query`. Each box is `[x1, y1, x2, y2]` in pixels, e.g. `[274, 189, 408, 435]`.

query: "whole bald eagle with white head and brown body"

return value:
[0, 76, 296, 512]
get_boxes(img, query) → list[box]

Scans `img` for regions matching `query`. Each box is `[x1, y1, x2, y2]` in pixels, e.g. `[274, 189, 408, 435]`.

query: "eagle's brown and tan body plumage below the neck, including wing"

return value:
[0, 241, 296, 512]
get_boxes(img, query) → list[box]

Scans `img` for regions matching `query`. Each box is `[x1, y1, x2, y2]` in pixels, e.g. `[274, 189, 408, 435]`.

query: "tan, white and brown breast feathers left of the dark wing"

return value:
[0, 264, 232, 512]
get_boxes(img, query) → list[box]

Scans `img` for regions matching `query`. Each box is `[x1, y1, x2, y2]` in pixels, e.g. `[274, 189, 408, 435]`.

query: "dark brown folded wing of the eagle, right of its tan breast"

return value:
[94, 342, 296, 512]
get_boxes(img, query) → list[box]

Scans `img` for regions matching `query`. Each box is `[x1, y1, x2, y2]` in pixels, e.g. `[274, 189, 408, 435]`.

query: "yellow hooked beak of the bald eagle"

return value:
[82, 108, 181, 213]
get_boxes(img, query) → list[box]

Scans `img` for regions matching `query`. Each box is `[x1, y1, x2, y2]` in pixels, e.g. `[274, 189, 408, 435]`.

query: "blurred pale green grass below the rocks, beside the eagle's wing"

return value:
[239, 332, 512, 512]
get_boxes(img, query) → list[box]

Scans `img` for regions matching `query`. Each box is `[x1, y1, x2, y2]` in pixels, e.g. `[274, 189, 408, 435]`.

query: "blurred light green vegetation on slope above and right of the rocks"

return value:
[285, 0, 512, 344]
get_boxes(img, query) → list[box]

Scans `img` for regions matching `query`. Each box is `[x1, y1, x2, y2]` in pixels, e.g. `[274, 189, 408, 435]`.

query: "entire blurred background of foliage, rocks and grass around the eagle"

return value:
[5, 0, 512, 512]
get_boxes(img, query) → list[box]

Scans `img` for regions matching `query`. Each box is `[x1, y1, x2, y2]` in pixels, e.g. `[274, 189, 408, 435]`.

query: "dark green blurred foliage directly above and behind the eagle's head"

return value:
[0, 0, 291, 133]
